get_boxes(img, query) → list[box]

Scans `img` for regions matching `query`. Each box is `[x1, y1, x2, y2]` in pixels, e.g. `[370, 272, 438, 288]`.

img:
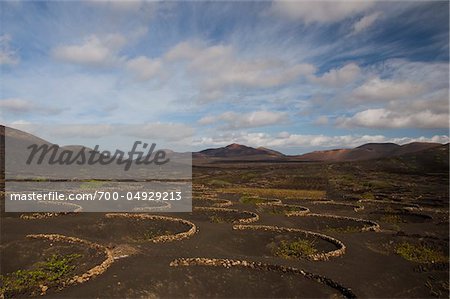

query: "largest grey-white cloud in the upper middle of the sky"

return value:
[165, 42, 316, 100]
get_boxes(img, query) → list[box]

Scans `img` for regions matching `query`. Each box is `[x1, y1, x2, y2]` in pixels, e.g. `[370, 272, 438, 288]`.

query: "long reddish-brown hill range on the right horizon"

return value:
[297, 142, 442, 162]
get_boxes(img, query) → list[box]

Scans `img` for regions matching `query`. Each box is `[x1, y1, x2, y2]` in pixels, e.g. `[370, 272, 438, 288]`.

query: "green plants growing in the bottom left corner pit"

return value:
[0, 254, 81, 298]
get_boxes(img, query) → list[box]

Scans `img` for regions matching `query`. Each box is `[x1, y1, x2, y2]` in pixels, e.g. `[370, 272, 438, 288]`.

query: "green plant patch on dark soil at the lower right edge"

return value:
[395, 242, 448, 263]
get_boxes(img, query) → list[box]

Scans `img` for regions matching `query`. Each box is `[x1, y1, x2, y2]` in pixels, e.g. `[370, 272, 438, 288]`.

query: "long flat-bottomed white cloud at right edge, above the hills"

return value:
[336, 108, 449, 129]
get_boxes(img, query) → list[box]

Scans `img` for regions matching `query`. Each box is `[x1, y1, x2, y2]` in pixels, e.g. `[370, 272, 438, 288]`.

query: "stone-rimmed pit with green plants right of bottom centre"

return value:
[229, 225, 345, 260]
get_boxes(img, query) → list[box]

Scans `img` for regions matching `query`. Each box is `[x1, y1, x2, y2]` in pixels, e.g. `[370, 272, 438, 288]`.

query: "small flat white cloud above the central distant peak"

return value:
[198, 110, 289, 130]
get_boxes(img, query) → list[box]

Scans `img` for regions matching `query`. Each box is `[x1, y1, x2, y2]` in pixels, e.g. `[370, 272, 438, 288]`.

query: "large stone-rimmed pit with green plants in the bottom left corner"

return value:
[0, 235, 114, 298]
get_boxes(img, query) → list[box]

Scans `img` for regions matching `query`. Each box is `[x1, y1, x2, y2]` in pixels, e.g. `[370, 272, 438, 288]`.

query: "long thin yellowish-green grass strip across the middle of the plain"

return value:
[220, 187, 326, 200]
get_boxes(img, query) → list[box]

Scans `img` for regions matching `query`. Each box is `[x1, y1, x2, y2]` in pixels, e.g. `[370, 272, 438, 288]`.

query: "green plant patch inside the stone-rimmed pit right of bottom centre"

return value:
[274, 239, 317, 259]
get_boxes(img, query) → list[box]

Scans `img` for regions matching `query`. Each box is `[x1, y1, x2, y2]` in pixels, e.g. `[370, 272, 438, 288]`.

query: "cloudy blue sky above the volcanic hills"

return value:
[0, 1, 449, 154]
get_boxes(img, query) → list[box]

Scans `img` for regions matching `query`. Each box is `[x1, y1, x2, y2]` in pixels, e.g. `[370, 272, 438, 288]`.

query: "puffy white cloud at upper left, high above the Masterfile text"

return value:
[52, 34, 127, 66]
